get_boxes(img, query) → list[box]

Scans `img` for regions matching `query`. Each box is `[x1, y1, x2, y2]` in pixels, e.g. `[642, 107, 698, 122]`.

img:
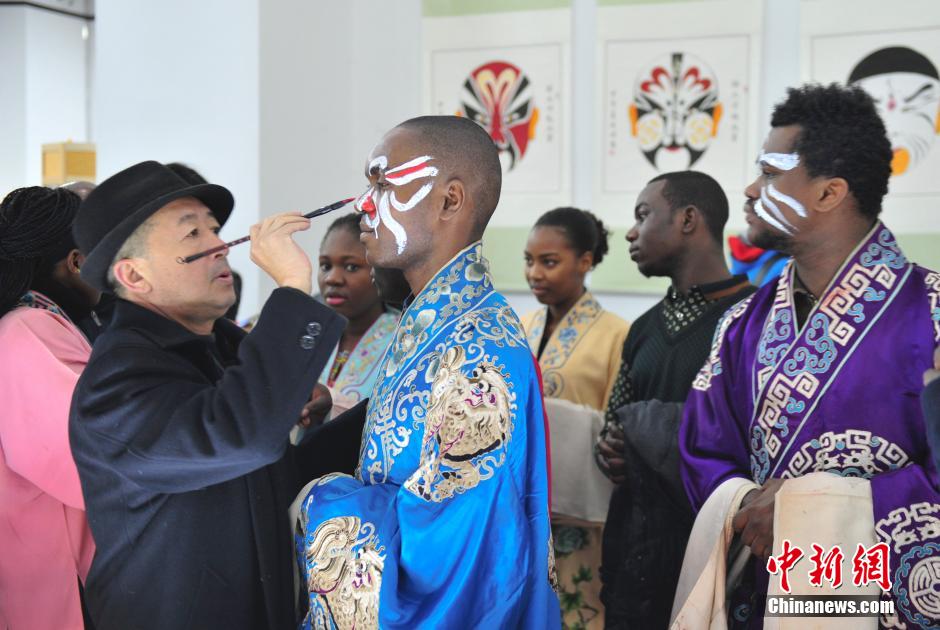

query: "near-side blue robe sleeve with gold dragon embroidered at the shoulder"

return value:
[382, 353, 557, 628]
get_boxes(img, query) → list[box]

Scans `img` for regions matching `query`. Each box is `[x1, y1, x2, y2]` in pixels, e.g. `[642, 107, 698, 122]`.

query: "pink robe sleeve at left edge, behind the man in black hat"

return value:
[0, 309, 90, 509]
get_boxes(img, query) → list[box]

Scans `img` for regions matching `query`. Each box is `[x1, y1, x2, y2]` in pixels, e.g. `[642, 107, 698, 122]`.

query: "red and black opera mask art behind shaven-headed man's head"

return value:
[457, 61, 539, 170]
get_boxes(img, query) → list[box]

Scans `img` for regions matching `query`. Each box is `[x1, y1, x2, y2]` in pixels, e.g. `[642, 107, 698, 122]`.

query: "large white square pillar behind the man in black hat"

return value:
[92, 0, 421, 317]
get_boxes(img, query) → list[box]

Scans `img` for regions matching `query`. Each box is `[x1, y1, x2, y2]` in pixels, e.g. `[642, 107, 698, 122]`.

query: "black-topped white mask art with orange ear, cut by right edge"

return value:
[849, 46, 940, 175]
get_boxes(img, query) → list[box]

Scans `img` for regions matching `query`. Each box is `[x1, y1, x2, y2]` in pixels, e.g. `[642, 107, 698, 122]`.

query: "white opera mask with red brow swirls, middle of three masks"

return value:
[628, 52, 722, 171]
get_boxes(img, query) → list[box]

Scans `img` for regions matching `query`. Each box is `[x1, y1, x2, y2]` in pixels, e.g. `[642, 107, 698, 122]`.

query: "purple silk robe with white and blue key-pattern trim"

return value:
[679, 222, 940, 628]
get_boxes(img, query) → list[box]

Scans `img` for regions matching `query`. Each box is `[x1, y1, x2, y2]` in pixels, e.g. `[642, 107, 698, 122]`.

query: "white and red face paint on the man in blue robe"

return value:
[356, 155, 438, 256]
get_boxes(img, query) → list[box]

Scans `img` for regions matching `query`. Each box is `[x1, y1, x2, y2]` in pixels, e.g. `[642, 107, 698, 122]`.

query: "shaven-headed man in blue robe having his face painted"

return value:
[295, 116, 560, 629]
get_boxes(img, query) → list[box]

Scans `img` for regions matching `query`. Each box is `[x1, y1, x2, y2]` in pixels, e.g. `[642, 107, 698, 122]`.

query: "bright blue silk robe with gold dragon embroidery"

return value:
[296, 243, 560, 630]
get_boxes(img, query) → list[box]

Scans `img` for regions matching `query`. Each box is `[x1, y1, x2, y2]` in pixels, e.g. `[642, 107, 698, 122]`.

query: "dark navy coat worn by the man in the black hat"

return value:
[69, 288, 364, 630]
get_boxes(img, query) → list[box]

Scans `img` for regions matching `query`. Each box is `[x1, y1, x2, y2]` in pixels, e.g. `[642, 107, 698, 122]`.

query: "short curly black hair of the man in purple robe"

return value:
[770, 83, 892, 219]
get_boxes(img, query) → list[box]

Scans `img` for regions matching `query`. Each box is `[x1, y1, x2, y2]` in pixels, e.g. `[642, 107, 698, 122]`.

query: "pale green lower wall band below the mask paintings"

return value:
[483, 227, 940, 295]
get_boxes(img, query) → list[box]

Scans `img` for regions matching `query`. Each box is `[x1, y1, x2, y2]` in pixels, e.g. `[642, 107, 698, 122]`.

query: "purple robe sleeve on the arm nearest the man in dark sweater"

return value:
[679, 311, 751, 512]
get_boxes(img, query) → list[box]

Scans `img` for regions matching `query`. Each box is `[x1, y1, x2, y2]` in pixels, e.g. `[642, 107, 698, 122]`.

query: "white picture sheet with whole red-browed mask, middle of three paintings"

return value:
[598, 27, 755, 198]
